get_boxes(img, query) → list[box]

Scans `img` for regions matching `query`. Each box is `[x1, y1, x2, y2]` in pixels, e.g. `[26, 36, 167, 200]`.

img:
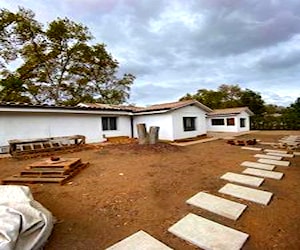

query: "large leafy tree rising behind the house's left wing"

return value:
[0, 8, 134, 105]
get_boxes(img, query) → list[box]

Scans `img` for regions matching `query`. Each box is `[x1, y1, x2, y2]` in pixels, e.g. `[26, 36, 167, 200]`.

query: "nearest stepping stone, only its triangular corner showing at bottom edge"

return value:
[106, 230, 172, 250]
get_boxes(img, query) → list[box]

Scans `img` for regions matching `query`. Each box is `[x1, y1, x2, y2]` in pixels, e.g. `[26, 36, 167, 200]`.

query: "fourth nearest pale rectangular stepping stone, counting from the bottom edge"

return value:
[219, 183, 273, 205]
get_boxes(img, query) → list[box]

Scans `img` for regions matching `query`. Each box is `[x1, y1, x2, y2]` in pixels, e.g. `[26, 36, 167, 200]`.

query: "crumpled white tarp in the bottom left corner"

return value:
[0, 185, 54, 250]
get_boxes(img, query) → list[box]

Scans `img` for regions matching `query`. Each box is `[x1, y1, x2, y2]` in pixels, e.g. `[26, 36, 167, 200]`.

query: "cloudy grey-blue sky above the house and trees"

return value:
[0, 0, 300, 105]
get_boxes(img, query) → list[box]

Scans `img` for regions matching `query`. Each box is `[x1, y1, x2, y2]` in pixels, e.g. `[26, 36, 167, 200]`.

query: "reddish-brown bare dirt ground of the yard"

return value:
[0, 131, 300, 250]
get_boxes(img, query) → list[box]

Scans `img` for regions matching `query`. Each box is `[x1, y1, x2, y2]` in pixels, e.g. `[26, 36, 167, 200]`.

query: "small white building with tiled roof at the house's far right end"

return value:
[207, 107, 254, 132]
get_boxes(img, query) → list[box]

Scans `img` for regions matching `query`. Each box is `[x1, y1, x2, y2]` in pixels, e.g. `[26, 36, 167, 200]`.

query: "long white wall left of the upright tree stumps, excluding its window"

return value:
[0, 112, 131, 146]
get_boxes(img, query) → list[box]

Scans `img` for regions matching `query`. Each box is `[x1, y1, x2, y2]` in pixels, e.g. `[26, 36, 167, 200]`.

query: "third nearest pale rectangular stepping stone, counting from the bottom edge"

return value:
[186, 192, 247, 220]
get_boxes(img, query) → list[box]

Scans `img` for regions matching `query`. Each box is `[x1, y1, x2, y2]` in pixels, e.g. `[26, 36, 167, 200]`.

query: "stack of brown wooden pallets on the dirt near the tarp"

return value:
[2, 158, 89, 185]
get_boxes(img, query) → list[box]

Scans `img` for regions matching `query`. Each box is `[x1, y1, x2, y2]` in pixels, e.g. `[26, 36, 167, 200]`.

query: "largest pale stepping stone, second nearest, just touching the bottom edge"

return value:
[168, 213, 249, 250]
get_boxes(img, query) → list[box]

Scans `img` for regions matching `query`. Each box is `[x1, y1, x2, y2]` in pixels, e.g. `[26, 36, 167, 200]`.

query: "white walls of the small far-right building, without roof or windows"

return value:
[206, 111, 250, 132]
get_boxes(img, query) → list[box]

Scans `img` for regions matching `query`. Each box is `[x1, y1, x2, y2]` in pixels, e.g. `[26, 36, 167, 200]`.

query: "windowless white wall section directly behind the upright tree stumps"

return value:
[133, 113, 174, 141]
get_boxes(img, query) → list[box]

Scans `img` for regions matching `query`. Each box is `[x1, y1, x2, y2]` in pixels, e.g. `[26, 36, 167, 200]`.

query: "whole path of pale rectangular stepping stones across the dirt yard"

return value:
[107, 135, 300, 250]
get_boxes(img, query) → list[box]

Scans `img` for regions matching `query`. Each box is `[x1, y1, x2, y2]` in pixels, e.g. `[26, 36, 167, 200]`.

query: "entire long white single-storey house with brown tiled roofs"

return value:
[0, 100, 253, 146]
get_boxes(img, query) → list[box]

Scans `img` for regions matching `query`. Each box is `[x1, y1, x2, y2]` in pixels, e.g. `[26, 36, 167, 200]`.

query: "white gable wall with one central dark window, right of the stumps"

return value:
[172, 106, 207, 140]
